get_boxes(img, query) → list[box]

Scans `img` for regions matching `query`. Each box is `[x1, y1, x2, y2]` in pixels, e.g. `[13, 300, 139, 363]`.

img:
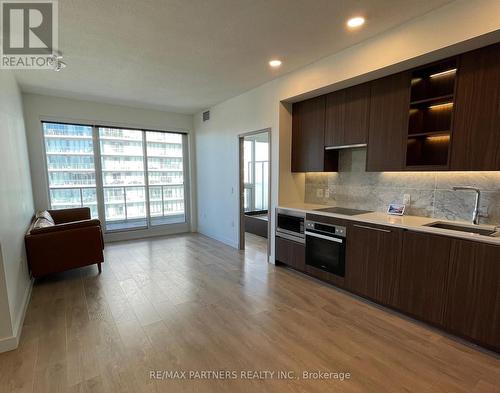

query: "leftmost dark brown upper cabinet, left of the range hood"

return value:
[292, 96, 338, 172]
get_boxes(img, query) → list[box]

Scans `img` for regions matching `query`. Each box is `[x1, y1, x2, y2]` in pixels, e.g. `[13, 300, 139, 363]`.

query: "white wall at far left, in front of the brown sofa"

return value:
[0, 70, 34, 352]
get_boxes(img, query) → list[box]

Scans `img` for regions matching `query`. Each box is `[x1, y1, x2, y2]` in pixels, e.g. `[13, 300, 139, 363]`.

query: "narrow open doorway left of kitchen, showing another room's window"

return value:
[239, 129, 271, 256]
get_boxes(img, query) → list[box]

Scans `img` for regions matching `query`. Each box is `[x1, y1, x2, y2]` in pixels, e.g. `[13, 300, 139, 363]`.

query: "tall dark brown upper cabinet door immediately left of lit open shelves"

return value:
[366, 71, 411, 172]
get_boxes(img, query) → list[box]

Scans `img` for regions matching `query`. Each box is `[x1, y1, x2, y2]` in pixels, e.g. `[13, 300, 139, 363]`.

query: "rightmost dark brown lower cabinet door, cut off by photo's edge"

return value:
[444, 240, 500, 351]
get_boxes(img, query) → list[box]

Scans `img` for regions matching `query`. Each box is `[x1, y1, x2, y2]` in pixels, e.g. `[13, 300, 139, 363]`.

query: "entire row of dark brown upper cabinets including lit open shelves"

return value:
[292, 43, 500, 172]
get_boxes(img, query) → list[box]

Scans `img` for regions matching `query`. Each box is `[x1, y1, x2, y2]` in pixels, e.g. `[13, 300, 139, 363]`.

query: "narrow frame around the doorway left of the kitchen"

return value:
[238, 127, 273, 254]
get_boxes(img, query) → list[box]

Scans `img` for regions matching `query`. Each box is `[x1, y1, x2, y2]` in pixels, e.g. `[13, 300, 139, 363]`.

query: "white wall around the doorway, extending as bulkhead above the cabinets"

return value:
[194, 0, 500, 256]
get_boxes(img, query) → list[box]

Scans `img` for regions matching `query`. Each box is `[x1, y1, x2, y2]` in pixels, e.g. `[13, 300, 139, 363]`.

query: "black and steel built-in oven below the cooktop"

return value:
[305, 220, 346, 277]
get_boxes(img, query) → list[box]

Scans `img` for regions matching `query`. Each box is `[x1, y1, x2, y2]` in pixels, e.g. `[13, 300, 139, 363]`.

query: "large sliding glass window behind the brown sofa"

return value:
[43, 122, 186, 231]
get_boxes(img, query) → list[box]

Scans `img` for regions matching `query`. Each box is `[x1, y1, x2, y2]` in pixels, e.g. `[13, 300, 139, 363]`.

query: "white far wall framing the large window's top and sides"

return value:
[23, 94, 196, 229]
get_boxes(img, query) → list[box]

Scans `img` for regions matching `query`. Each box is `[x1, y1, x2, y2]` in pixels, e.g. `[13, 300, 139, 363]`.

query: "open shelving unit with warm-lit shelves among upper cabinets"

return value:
[406, 59, 457, 169]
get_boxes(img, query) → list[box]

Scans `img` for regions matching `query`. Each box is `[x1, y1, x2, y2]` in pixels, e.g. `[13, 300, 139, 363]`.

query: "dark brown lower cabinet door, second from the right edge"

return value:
[397, 231, 453, 326]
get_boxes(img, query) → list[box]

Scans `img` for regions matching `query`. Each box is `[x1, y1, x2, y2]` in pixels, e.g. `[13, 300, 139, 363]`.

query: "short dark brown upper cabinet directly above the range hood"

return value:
[325, 83, 371, 147]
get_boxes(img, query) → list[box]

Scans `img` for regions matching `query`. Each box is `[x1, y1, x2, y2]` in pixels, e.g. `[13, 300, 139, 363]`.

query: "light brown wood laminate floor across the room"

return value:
[0, 234, 500, 393]
